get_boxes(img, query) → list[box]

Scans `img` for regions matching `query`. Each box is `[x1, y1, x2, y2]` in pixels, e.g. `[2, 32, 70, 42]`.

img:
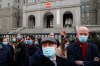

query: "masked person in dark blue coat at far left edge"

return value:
[0, 38, 12, 66]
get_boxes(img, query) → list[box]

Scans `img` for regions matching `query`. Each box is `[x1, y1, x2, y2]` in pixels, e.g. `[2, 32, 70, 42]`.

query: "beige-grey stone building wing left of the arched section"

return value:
[0, 0, 25, 33]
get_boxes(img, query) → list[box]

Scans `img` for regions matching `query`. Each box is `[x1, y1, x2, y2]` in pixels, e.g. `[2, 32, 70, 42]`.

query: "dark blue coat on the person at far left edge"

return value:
[0, 44, 11, 66]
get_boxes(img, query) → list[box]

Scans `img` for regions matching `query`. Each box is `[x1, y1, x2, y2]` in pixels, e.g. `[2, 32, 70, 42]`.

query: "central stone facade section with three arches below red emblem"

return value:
[21, 0, 81, 33]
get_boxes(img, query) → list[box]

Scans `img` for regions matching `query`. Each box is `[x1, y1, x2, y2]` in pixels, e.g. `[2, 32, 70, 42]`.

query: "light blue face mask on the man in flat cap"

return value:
[42, 47, 56, 58]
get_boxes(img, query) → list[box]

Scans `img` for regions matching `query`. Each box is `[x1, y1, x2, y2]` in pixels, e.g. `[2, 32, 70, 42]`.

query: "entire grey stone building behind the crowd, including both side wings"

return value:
[0, 0, 100, 33]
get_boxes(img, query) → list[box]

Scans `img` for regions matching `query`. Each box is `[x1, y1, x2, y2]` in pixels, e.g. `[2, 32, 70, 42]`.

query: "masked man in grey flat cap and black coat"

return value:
[33, 37, 69, 66]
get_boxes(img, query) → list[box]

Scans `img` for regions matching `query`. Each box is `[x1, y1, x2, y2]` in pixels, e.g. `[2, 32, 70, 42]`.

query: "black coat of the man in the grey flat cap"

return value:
[33, 56, 69, 66]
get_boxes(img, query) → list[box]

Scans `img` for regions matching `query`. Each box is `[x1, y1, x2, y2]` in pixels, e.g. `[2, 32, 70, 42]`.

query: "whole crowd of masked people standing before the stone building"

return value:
[0, 26, 100, 66]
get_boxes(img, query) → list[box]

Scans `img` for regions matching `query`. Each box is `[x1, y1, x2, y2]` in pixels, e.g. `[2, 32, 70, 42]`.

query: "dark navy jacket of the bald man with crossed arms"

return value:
[67, 42, 99, 66]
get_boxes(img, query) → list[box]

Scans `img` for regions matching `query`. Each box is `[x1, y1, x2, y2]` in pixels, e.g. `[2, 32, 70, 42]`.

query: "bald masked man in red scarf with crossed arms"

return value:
[67, 27, 100, 66]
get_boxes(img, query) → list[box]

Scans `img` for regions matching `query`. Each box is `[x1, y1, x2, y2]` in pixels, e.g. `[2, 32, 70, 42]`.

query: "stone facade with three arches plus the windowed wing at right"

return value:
[21, 0, 100, 33]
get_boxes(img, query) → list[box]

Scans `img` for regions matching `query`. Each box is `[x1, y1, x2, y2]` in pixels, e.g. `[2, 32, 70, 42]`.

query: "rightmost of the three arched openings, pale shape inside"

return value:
[63, 11, 73, 28]
